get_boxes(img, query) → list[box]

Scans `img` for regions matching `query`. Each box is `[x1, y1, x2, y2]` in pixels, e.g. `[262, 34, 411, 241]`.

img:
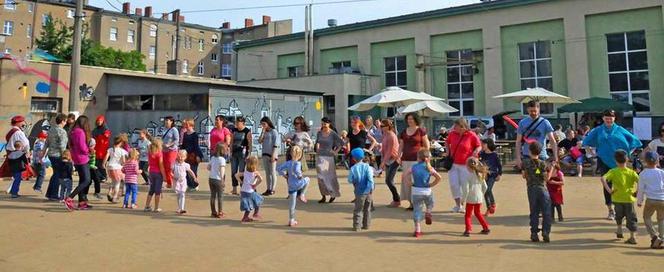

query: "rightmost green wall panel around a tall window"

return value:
[586, 7, 664, 115]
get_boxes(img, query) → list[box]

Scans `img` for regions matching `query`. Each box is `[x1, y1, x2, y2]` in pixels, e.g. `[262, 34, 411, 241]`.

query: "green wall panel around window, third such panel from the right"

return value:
[430, 30, 486, 115]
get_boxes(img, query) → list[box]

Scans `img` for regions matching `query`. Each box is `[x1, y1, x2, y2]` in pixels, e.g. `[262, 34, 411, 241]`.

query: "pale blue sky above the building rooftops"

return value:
[89, 0, 480, 32]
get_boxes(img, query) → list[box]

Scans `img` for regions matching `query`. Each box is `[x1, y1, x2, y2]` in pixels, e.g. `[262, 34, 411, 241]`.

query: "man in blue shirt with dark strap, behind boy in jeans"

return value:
[516, 100, 558, 167]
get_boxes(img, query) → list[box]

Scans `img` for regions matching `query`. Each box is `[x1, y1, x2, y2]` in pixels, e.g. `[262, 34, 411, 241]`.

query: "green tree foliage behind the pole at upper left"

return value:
[37, 15, 146, 71]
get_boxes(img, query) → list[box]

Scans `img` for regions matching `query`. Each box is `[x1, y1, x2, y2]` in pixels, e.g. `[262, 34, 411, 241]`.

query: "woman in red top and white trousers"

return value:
[446, 117, 482, 213]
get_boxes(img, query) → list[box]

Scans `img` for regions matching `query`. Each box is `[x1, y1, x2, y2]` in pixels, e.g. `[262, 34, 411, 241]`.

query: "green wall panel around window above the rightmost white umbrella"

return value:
[500, 20, 578, 111]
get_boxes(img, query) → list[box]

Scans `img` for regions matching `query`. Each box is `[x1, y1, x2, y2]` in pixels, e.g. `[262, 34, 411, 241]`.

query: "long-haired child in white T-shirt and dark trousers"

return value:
[208, 143, 226, 218]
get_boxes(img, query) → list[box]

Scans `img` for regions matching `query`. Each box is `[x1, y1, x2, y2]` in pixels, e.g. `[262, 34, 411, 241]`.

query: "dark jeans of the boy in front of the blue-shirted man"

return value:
[528, 186, 551, 235]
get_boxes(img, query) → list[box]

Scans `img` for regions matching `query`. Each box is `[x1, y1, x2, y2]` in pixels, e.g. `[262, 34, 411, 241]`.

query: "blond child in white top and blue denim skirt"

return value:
[235, 156, 263, 222]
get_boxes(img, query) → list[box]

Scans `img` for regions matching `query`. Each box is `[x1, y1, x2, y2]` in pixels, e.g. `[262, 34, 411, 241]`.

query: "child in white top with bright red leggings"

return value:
[461, 157, 491, 237]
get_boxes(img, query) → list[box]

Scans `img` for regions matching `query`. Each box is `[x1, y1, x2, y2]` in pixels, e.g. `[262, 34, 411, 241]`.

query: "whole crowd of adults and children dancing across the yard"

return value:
[1, 101, 664, 248]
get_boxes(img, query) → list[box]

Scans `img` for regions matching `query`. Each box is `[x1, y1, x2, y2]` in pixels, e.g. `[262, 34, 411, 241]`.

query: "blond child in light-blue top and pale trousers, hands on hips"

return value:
[277, 145, 309, 227]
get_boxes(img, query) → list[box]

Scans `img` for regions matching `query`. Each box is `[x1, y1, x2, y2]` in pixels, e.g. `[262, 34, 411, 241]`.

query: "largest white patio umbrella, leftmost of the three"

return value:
[348, 87, 443, 111]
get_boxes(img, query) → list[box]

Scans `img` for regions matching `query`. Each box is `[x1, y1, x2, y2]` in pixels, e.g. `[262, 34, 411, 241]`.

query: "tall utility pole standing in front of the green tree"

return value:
[69, 0, 84, 112]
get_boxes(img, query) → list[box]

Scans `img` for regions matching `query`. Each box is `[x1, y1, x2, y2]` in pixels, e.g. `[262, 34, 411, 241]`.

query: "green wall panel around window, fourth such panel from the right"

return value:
[369, 39, 416, 91]
